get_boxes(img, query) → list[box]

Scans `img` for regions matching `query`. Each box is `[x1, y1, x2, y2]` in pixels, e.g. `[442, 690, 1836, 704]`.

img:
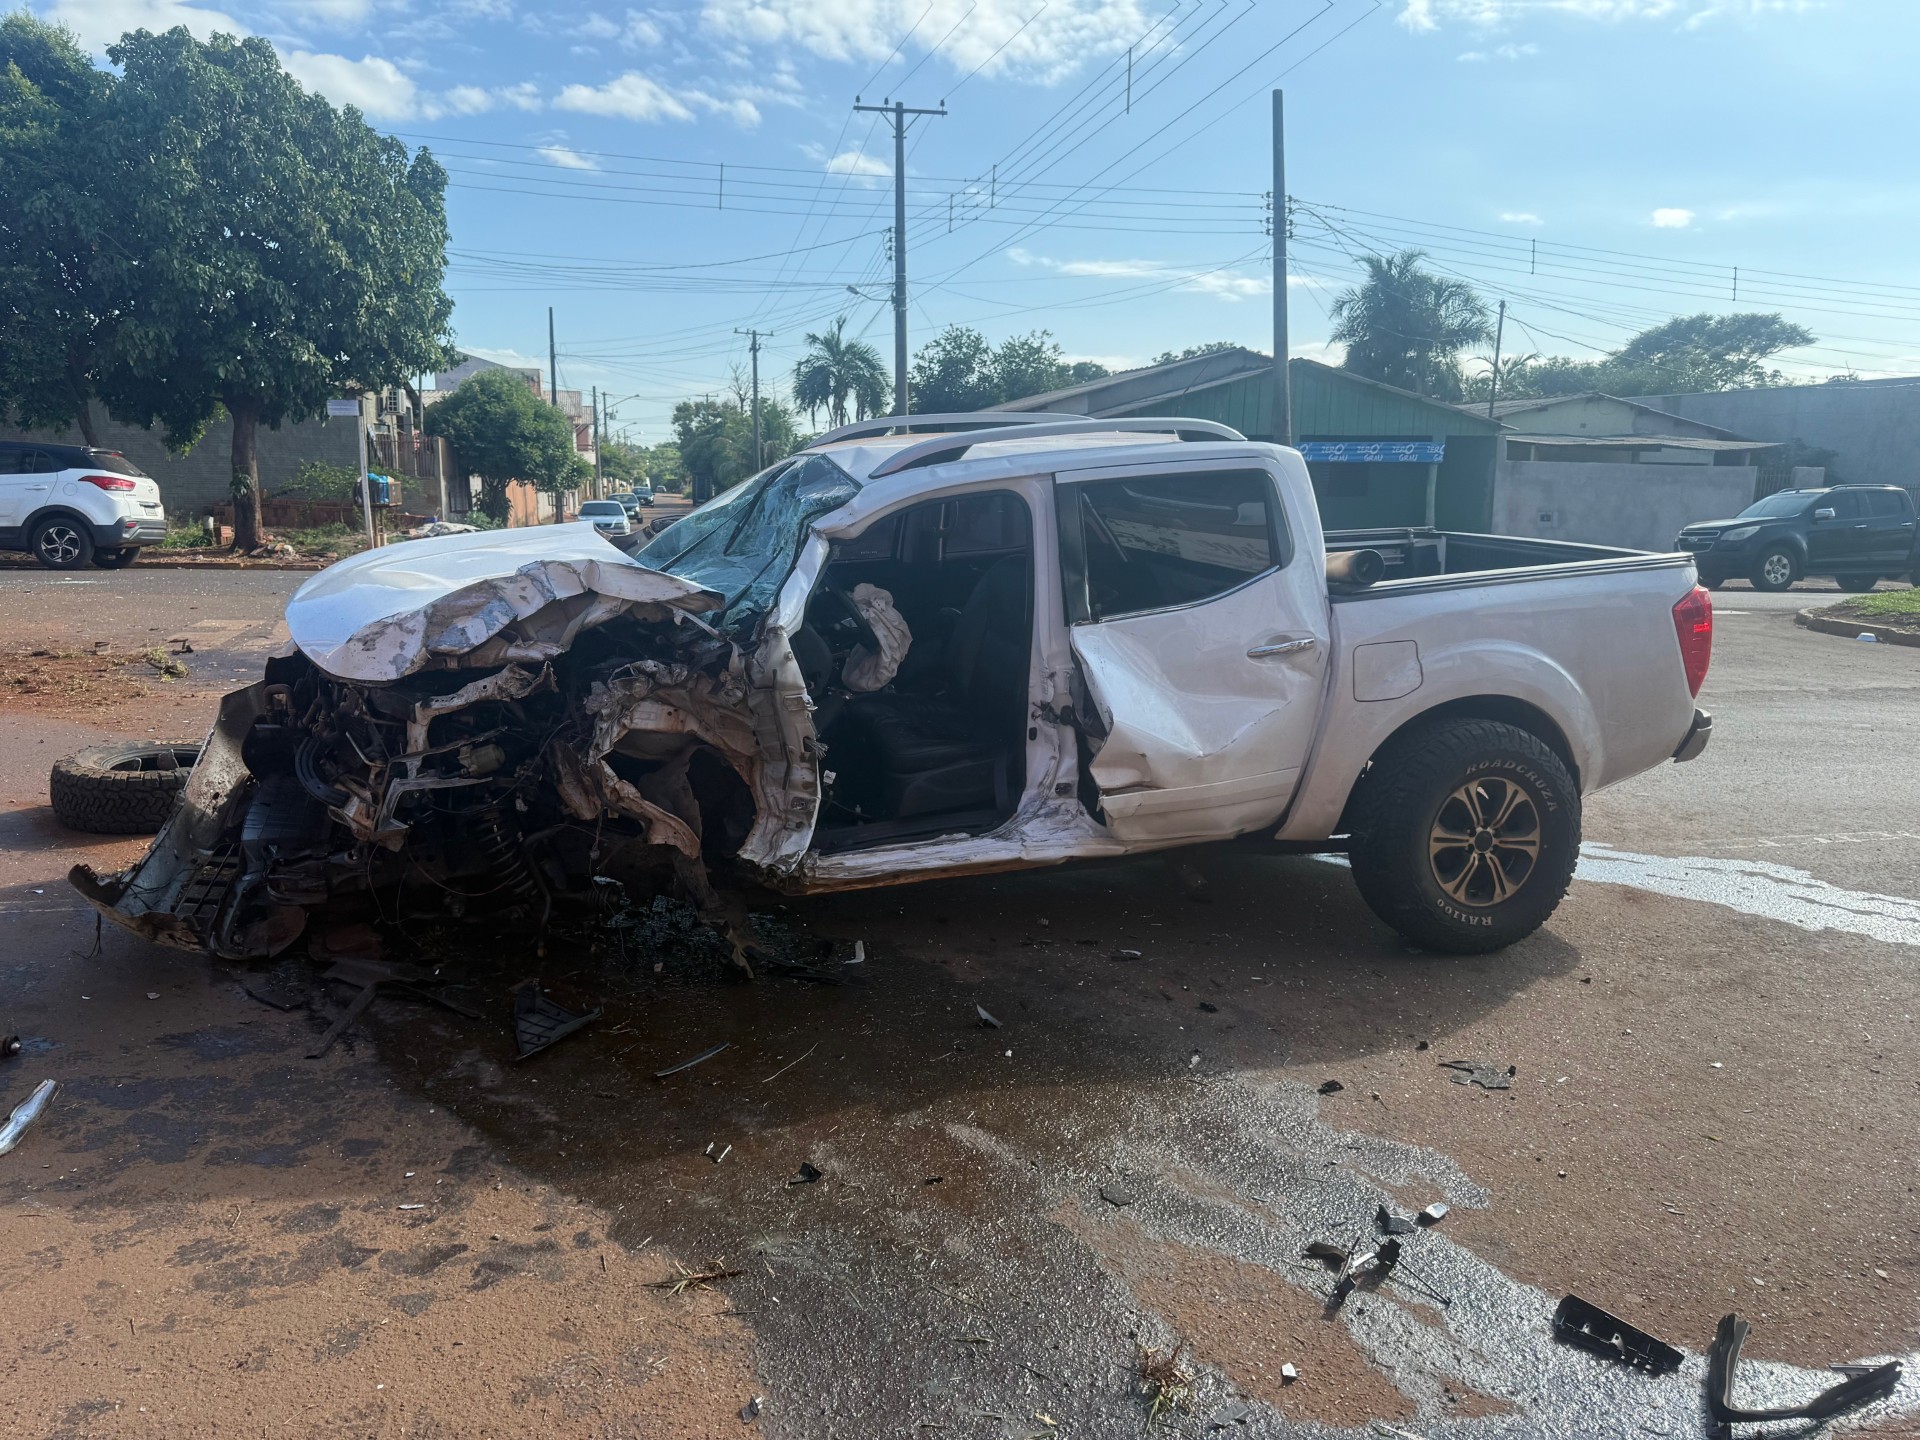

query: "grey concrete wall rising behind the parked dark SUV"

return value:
[1640, 376, 1920, 490]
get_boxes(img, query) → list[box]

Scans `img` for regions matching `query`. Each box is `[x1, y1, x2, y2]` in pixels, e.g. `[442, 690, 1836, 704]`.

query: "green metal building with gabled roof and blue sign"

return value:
[1000, 349, 1503, 532]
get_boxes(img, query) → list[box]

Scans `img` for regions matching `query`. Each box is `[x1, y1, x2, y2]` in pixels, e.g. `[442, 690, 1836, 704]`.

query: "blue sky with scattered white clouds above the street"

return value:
[33, 0, 1920, 442]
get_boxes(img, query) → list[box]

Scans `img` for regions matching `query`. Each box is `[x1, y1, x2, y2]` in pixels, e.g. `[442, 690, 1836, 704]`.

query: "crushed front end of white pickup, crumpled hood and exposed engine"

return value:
[71, 526, 810, 960]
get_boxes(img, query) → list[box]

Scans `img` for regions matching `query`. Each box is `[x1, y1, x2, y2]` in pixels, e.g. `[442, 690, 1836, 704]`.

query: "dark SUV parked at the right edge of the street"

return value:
[1674, 486, 1920, 589]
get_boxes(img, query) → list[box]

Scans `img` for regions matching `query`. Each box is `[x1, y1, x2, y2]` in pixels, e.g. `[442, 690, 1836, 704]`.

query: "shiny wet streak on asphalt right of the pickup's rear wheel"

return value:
[1574, 845, 1920, 945]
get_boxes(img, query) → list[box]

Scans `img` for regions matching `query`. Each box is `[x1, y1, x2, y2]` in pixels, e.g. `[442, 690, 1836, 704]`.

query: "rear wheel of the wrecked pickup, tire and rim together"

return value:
[1350, 720, 1580, 954]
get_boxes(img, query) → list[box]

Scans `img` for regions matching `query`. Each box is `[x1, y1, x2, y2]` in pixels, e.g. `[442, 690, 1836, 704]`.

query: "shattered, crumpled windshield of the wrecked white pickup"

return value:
[634, 455, 860, 626]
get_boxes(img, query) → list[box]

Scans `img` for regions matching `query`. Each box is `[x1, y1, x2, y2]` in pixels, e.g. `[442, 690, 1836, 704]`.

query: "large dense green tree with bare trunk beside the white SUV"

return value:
[102, 27, 453, 549]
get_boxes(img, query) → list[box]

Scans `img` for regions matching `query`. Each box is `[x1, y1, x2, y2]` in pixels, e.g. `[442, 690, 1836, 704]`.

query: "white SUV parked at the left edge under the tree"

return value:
[0, 440, 167, 570]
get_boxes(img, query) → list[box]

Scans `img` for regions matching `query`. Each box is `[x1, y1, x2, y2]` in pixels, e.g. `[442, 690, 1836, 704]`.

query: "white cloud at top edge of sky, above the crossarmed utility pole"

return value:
[701, 0, 1173, 84]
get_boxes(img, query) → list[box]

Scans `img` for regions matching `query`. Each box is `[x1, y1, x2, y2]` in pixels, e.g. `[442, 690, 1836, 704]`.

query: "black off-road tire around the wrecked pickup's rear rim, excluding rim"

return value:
[1348, 720, 1580, 954]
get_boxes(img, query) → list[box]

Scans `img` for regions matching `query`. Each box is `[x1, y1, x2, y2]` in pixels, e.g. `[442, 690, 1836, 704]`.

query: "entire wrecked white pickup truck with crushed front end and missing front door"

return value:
[73, 415, 1713, 958]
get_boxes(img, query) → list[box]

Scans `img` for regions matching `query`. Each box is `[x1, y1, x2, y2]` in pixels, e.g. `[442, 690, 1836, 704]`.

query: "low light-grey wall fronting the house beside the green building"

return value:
[1494, 461, 1759, 551]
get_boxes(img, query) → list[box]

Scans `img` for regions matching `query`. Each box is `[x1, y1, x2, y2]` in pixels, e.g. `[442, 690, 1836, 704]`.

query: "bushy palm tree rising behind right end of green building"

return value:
[1331, 250, 1490, 399]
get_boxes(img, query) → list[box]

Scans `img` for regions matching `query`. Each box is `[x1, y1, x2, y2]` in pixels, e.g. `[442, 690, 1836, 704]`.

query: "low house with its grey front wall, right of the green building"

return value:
[1461, 392, 1789, 551]
